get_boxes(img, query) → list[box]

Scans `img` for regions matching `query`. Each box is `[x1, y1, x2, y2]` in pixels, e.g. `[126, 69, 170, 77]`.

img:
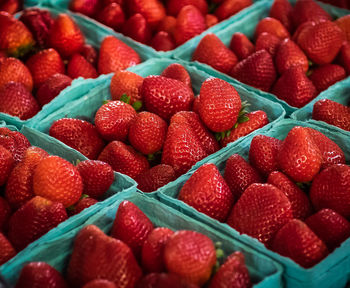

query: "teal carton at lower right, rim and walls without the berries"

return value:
[156, 119, 350, 288]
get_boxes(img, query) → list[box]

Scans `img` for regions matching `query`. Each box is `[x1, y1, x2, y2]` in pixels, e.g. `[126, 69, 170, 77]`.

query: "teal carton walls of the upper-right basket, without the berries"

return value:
[174, 0, 348, 115]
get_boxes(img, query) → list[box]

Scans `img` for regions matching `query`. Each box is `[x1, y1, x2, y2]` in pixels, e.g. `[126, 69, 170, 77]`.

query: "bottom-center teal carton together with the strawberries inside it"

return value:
[0, 192, 282, 288]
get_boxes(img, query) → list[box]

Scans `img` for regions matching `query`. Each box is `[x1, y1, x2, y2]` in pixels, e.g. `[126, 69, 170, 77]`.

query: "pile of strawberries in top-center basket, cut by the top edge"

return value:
[69, 0, 253, 51]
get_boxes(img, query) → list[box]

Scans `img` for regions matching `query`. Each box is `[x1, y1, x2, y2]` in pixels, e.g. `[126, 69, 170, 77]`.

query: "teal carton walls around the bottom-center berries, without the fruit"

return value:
[0, 192, 282, 288]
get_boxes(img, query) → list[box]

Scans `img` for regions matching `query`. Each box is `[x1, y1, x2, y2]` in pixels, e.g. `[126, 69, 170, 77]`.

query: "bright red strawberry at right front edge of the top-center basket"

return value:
[174, 5, 207, 46]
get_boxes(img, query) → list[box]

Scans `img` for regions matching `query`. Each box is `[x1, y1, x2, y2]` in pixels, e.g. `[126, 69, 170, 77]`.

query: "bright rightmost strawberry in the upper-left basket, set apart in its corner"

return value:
[98, 36, 141, 74]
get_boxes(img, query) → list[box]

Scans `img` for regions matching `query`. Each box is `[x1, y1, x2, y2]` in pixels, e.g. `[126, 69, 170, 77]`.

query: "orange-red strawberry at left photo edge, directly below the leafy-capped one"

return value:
[0, 57, 33, 92]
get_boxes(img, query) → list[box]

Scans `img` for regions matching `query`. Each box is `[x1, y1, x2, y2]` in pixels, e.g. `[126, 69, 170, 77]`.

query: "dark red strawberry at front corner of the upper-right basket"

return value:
[271, 66, 317, 108]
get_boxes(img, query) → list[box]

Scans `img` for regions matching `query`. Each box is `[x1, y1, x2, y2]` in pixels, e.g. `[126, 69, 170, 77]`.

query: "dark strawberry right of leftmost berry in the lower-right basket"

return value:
[224, 154, 262, 201]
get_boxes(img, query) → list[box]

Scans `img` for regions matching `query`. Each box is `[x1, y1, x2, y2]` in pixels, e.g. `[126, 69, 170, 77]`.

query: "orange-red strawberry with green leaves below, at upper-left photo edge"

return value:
[0, 11, 35, 57]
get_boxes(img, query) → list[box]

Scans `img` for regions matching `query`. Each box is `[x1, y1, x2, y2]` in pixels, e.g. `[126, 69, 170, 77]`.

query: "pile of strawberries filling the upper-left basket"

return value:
[0, 8, 141, 120]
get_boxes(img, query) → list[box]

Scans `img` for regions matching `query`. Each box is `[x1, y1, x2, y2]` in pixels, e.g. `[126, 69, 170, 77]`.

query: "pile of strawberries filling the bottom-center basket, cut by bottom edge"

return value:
[16, 200, 252, 288]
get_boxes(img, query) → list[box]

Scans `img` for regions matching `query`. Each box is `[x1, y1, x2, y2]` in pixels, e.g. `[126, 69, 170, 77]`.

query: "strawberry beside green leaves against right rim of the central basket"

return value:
[220, 110, 269, 147]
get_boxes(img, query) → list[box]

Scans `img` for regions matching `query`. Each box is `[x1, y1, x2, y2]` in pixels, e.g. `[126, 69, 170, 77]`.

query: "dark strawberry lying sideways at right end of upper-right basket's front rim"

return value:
[309, 64, 346, 92]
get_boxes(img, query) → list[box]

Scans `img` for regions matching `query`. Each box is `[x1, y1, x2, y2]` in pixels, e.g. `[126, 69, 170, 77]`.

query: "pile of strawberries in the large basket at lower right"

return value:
[178, 126, 350, 268]
